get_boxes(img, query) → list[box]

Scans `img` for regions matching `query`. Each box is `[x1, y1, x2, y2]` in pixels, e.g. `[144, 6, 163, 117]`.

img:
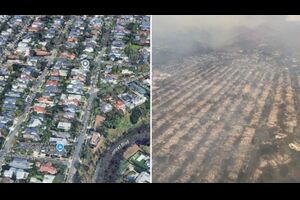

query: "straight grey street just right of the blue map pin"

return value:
[67, 70, 99, 183]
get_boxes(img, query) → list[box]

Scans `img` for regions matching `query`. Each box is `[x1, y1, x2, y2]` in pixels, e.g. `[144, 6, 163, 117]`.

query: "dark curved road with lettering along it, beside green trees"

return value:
[92, 128, 150, 183]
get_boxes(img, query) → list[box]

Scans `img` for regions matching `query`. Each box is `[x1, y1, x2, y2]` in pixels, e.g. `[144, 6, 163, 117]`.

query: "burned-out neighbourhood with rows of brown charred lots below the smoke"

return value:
[152, 49, 300, 182]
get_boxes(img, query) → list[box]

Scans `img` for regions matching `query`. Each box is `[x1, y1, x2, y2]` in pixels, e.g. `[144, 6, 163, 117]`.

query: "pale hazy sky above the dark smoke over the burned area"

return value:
[152, 15, 300, 45]
